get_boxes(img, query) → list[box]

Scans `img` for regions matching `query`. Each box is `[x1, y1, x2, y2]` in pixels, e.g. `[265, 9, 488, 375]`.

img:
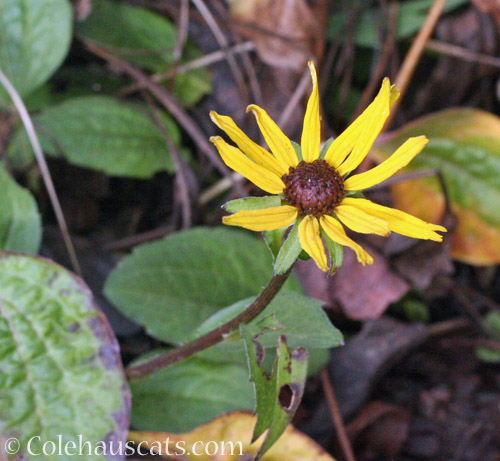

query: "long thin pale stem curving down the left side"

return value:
[0, 69, 82, 277]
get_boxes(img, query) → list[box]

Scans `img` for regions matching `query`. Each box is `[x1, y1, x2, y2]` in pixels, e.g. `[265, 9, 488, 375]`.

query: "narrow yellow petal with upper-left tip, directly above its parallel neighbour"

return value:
[210, 110, 288, 177]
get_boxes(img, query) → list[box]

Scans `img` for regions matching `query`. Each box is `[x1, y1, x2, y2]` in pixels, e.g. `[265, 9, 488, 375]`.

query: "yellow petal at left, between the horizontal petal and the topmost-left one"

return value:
[210, 136, 285, 194]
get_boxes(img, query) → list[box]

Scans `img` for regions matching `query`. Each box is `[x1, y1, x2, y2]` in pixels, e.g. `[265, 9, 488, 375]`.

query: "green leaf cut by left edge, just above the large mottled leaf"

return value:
[0, 164, 42, 253]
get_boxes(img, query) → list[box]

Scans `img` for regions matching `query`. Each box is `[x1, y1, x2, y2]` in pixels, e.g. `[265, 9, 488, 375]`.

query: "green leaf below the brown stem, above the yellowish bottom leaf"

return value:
[130, 358, 254, 432]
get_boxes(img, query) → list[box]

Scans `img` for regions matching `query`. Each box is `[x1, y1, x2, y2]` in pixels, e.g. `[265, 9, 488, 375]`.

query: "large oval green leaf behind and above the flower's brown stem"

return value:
[105, 227, 299, 344]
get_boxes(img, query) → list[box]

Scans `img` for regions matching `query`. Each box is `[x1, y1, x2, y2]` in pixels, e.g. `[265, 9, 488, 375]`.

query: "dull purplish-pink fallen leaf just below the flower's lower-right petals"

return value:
[296, 244, 410, 320]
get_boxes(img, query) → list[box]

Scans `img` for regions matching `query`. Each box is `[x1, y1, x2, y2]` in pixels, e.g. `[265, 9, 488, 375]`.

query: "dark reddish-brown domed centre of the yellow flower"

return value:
[281, 159, 346, 216]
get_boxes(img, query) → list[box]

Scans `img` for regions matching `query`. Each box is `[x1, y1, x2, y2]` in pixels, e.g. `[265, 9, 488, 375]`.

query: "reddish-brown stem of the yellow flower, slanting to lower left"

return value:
[126, 269, 291, 380]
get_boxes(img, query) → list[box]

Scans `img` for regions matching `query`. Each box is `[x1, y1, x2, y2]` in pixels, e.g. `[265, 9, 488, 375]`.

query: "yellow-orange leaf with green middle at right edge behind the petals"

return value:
[375, 109, 500, 265]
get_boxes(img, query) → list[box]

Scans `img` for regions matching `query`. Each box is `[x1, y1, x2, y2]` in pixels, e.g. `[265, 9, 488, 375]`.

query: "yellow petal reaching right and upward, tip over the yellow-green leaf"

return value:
[344, 136, 428, 190]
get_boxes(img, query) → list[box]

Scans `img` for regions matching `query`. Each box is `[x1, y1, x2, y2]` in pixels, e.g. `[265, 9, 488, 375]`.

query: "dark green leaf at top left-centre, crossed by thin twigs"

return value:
[77, 0, 212, 105]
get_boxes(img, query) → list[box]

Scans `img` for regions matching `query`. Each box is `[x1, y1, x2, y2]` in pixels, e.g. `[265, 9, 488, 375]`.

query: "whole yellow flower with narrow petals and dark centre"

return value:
[210, 62, 446, 271]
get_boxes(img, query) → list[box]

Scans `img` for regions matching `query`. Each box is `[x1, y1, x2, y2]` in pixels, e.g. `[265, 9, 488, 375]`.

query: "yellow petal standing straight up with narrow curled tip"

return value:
[300, 61, 321, 162]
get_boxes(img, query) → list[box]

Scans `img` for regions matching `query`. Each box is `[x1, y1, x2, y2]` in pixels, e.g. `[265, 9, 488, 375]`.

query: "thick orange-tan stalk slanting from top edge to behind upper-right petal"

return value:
[385, 0, 446, 129]
